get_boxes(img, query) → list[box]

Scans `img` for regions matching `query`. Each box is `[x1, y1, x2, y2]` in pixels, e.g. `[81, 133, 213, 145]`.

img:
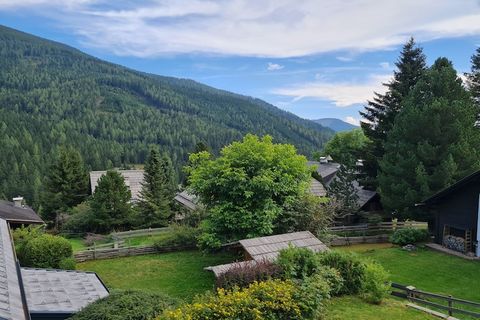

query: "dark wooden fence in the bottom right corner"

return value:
[392, 283, 480, 318]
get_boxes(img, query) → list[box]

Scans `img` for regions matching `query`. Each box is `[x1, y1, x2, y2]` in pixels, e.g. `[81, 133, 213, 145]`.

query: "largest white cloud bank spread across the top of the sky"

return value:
[0, 0, 480, 59]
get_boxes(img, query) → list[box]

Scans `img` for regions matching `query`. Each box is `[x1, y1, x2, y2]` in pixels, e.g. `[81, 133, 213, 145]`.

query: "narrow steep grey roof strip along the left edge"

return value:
[0, 219, 27, 320]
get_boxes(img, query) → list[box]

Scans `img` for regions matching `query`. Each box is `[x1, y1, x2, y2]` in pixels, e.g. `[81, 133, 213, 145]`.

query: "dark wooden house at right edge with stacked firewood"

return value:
[420, 171, 480, 256]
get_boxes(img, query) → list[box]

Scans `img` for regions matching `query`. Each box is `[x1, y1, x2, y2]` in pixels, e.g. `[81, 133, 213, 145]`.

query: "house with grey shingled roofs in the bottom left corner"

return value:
[0, 219, 109, 320]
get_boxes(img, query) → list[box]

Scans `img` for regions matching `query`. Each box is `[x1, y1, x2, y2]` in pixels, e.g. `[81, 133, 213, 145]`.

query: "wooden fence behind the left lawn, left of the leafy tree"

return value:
[73, 245, 196, 262]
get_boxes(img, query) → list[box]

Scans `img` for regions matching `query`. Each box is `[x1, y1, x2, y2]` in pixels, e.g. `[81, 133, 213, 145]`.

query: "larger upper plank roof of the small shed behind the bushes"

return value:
[240, 231, 328, 261]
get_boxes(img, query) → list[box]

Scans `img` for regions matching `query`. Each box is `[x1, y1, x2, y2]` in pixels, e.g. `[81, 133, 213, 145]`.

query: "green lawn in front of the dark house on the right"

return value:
[337, 245, 480, 301]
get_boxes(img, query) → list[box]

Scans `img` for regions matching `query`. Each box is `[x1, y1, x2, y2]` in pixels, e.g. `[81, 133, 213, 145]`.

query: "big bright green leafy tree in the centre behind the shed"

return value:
[186, 134, 311, 247]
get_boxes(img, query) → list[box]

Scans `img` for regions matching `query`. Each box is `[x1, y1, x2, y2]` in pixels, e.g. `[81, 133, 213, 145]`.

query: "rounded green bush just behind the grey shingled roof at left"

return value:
[20, 234, 73, 269]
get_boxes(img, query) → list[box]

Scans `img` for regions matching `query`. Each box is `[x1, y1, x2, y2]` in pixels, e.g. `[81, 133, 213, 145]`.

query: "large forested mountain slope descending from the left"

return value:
[0, 26, 333, 203]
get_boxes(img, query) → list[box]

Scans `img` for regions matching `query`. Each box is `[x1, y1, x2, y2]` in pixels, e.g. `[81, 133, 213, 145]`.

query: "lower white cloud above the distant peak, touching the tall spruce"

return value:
[272, 74, 391, 107]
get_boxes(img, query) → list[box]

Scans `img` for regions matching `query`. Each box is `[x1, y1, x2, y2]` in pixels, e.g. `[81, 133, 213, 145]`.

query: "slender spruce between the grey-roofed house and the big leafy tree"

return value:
[139, 148, 176, 227]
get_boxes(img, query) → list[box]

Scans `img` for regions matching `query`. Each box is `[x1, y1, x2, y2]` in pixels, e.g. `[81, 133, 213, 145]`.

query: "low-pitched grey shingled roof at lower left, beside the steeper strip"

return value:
[21, 268, 108, 313]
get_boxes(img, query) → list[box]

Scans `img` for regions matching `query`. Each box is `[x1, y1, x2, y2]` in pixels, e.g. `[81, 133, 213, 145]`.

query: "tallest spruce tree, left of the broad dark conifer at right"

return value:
[360, 38, 426, 189]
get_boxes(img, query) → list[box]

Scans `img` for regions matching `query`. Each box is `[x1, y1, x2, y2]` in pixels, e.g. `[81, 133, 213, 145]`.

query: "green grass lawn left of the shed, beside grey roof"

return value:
[77, 251, 235, 301]
